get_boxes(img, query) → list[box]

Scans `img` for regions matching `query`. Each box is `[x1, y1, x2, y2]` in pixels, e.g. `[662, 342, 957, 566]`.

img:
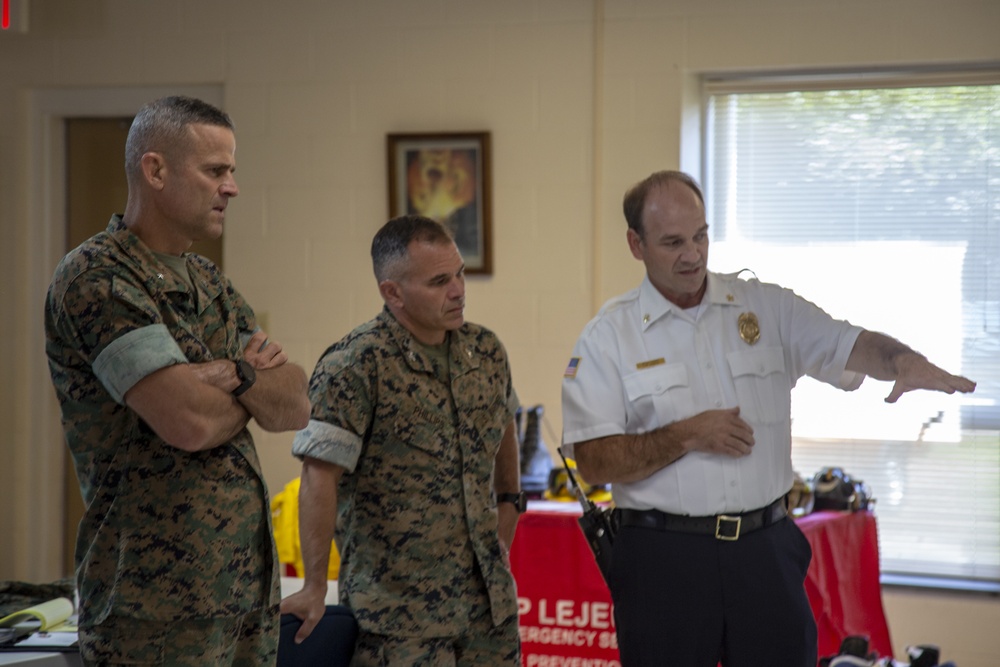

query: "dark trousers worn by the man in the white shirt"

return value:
[609, 519, 817, 667]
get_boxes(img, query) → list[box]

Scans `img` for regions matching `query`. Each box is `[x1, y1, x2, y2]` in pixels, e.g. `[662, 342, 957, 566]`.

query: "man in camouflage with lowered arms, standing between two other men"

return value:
[281, 216, 524, 667]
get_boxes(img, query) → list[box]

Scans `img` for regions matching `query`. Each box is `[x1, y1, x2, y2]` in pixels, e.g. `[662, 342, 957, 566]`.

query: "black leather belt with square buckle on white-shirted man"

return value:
[615, 498, 787, 542]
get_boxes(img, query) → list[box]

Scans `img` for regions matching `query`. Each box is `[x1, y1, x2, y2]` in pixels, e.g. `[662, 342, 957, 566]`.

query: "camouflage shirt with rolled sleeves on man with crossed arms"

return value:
[45, 216, 279, 664]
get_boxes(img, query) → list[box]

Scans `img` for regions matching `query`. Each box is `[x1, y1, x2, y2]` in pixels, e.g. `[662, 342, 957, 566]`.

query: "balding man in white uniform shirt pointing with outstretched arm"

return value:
[563, 171, 975, 667]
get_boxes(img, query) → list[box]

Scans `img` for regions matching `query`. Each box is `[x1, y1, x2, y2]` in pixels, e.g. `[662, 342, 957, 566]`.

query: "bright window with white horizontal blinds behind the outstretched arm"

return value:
[703, 72, 1000, 581]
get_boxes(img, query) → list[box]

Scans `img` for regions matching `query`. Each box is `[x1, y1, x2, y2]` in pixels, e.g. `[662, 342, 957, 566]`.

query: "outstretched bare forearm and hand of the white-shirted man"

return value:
[847, 331, 976, 403]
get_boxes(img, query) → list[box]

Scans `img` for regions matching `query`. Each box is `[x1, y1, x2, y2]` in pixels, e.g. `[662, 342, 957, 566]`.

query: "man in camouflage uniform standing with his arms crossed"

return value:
[45, 98, 309, 665]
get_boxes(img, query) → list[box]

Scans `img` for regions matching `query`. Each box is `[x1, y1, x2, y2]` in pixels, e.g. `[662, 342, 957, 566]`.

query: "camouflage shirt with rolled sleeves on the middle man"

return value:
[293, 309, 519, 640]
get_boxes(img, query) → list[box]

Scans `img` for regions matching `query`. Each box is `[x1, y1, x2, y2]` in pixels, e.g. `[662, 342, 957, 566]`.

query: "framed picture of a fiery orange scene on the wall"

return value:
[387, 132, 493, 275]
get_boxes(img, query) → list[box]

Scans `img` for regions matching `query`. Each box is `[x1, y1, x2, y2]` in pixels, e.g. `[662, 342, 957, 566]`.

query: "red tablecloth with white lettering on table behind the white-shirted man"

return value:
[511, 505, 892, 667]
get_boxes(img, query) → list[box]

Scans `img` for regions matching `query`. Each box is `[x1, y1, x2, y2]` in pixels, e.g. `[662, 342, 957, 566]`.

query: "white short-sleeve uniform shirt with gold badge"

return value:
[562, 273, 864, 516]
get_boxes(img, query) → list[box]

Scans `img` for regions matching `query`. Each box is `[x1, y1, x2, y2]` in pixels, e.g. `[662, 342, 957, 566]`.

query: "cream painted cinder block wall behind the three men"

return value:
[0, 0, 1000, 667]
